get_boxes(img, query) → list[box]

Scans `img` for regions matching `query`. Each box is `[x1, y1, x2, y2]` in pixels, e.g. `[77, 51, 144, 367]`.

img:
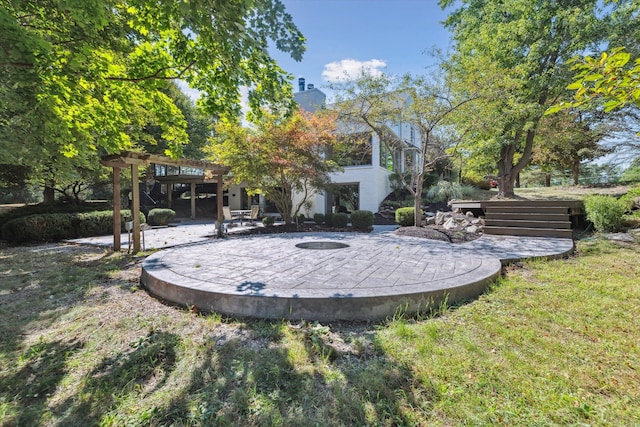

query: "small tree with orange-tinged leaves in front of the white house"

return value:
[210, 111, 339, 223]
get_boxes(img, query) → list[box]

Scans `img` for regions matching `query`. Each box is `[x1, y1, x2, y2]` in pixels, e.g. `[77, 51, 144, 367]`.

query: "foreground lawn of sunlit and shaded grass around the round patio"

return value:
[0, 185, 640, 426]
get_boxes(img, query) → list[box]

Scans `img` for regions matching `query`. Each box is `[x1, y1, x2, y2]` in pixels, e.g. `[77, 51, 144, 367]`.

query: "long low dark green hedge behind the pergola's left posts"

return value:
[2, 210, 145, 244]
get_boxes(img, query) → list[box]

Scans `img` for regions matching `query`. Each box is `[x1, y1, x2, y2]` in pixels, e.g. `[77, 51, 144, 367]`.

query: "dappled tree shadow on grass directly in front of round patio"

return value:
[135, 322, 432, 426]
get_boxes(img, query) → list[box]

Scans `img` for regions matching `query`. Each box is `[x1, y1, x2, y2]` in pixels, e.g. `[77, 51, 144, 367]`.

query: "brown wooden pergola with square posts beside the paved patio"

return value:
[101, 151, 230, 252]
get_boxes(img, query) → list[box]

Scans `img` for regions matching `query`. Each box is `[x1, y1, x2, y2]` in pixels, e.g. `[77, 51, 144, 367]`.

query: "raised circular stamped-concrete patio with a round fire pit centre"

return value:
[141, 233, 501, 321]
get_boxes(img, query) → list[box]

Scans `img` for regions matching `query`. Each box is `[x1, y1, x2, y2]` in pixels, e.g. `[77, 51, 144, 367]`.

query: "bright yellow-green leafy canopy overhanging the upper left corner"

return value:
[0, 0, 304, 201]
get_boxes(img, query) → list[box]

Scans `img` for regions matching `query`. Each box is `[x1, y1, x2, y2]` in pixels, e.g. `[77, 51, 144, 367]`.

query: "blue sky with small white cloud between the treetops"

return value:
[270, 0, 451, 100]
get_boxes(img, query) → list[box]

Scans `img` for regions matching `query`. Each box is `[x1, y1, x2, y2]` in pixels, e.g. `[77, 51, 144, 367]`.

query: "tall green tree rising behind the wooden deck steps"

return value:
[440, 0, 627, 197]
